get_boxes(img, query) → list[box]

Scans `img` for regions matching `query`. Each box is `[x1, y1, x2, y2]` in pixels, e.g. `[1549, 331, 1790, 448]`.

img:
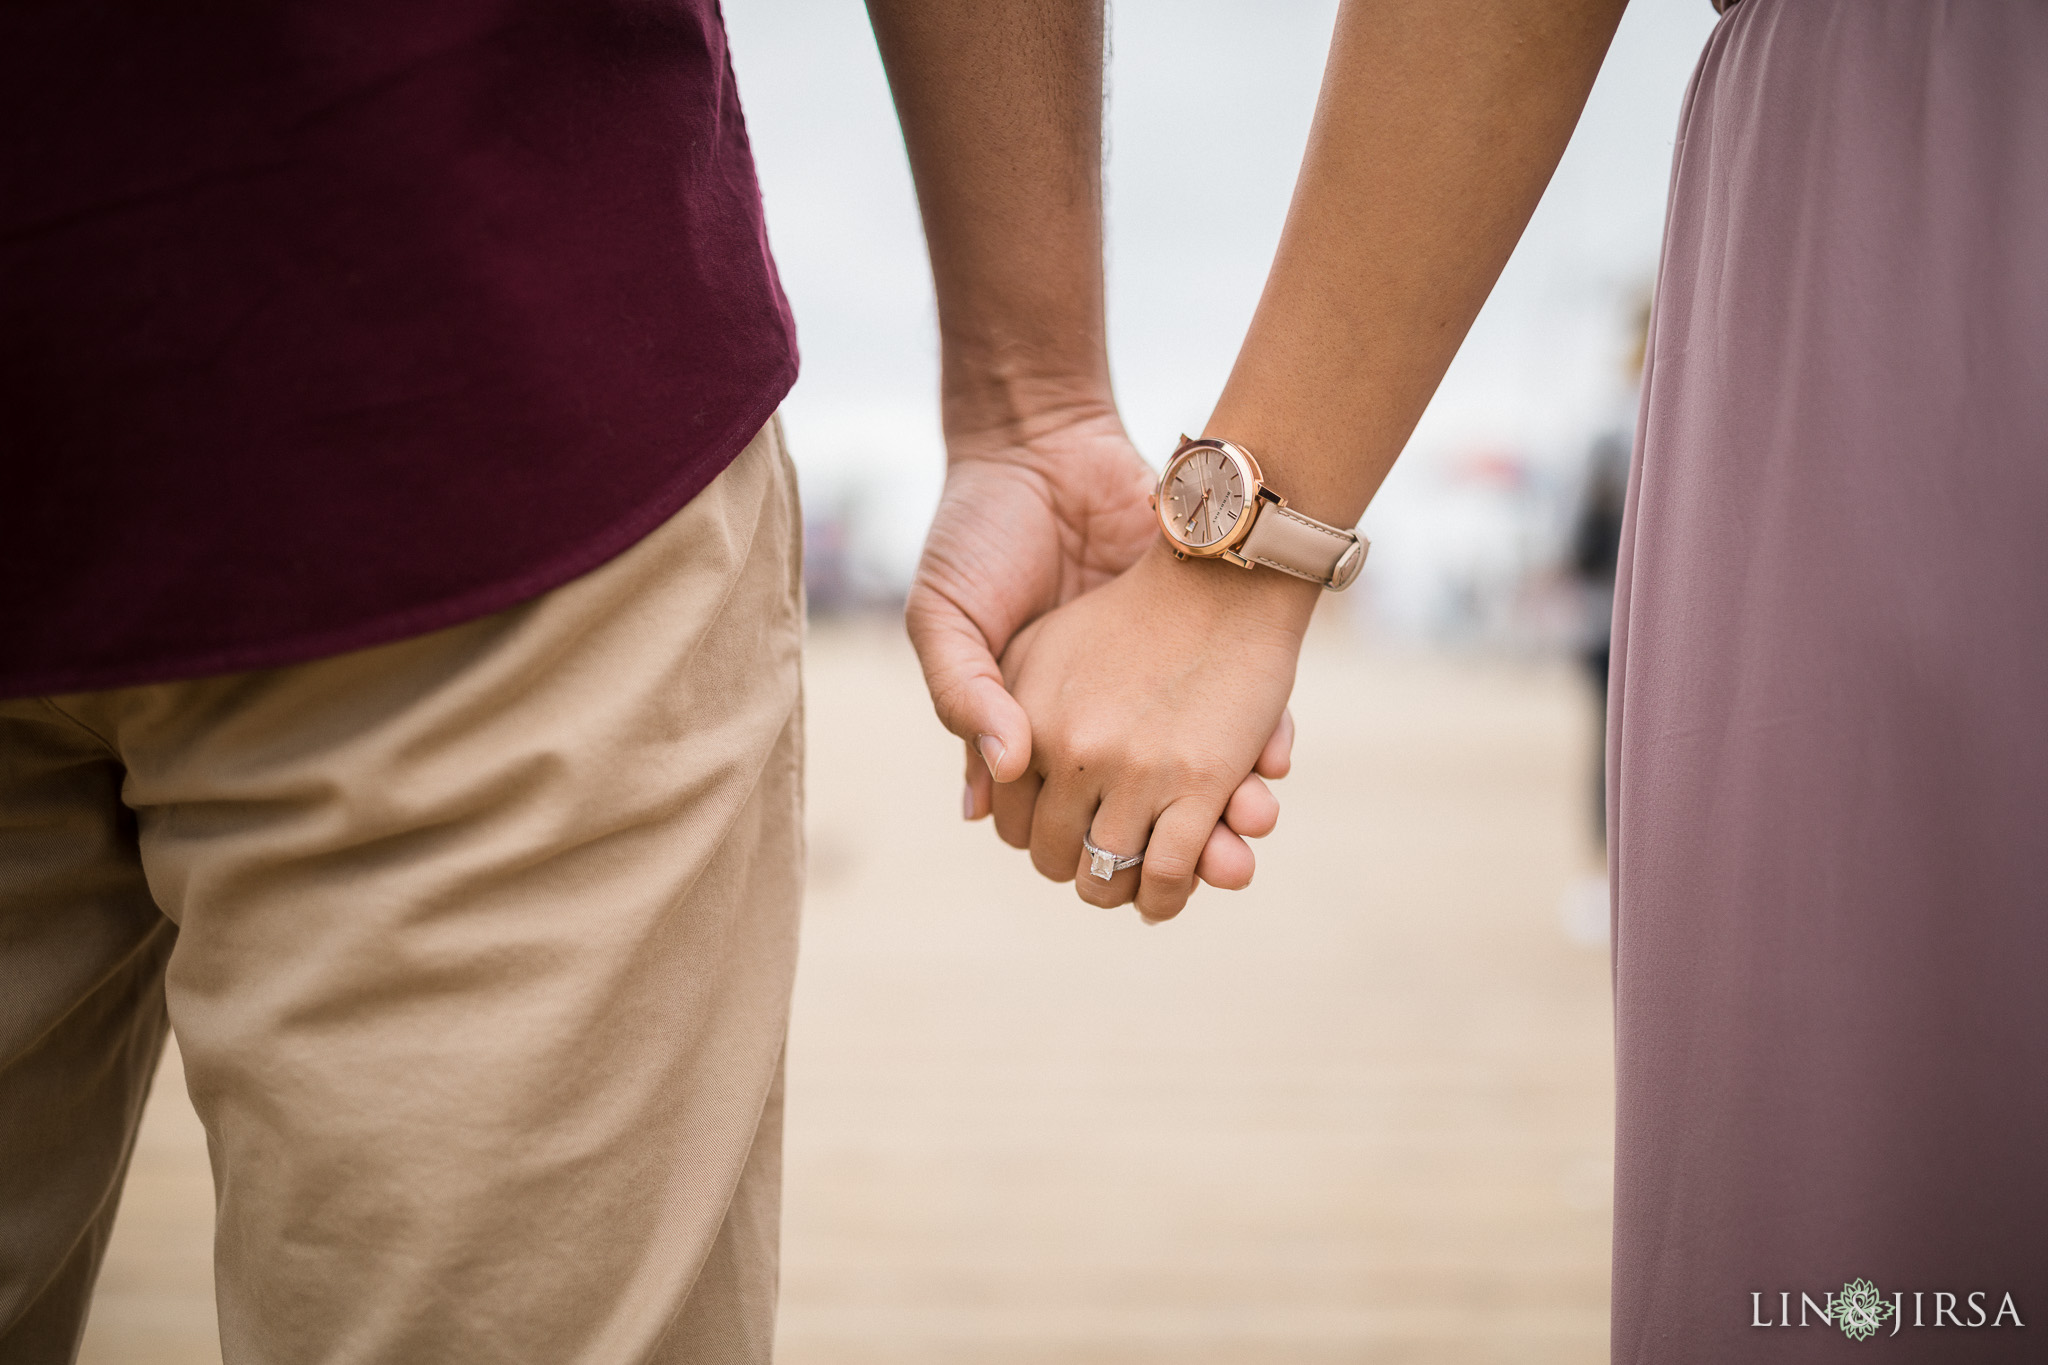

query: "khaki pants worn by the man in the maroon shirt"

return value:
[0, 424, 803, 1365]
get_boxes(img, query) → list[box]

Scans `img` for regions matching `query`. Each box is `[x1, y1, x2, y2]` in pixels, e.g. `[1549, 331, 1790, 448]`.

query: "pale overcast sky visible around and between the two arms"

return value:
[725, 0, 1714, 610]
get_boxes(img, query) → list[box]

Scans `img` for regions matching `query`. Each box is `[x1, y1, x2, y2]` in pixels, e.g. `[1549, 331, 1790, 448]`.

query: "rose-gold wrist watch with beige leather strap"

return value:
[1151, 436, 1372, 591]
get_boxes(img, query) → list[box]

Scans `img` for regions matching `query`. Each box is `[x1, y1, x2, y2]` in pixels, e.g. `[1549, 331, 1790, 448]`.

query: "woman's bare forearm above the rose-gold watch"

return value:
[1206, 0, 1624, 526]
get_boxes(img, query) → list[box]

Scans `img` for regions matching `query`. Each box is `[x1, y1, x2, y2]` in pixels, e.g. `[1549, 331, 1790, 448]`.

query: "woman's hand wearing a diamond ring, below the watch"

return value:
[995, 546, 1317, 921]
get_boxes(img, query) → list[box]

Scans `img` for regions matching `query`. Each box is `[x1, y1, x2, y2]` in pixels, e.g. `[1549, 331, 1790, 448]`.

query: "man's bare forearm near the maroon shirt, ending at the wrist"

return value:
[868, 0, 1110, 432]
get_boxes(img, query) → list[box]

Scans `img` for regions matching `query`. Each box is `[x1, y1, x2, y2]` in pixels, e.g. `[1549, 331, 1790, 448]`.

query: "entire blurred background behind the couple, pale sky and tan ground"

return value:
[84, 0, 1714, 1365]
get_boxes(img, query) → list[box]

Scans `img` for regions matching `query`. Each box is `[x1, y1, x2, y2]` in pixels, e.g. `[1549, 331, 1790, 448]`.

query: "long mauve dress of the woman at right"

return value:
[1610, 0, 2048, 1365]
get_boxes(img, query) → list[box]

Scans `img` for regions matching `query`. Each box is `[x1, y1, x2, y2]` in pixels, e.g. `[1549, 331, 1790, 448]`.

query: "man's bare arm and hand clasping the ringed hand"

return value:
[868, 0, 1286, 886]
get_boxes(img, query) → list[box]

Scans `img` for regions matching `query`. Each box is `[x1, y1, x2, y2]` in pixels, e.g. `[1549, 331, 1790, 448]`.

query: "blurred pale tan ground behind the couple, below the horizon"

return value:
[82, 622, 1612, 1365]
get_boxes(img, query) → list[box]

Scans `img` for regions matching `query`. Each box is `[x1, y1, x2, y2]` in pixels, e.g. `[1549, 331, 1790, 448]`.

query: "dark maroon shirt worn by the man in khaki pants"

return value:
[0, 0, 797, 696]
